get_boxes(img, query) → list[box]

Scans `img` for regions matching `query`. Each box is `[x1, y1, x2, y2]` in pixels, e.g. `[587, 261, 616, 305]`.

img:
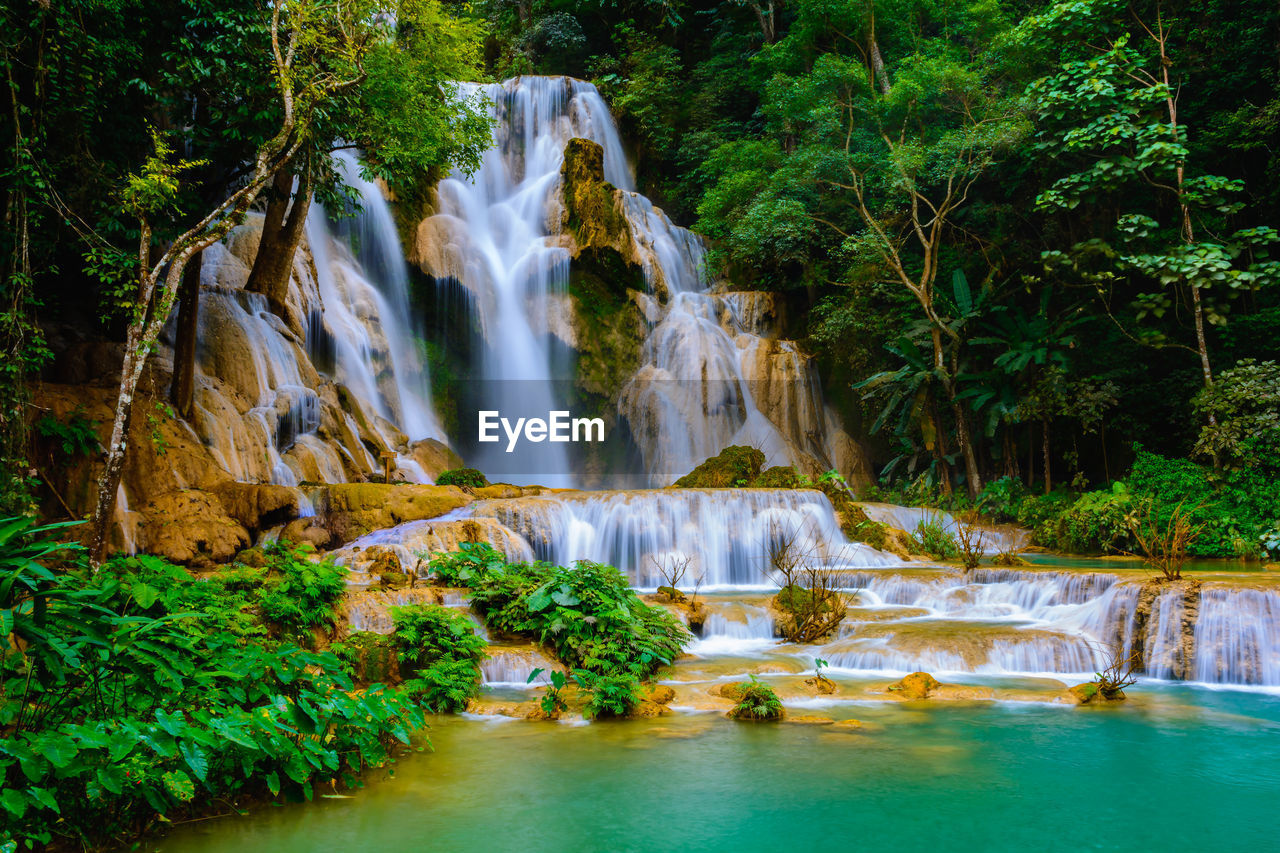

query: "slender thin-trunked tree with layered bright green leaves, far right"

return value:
[1014, 0, 1280, 399]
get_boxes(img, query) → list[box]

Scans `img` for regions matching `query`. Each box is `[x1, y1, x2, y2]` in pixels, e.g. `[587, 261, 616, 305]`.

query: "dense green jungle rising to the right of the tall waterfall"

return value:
[465, 0, 1280, 556]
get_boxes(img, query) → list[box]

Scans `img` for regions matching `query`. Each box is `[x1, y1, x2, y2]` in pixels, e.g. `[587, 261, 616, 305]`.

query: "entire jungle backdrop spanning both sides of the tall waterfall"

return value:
[0, 0, 1280, 552]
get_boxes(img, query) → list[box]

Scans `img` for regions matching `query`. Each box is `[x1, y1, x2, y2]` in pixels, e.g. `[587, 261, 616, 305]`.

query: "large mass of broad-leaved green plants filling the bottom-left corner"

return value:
[0, 520, 424, 848]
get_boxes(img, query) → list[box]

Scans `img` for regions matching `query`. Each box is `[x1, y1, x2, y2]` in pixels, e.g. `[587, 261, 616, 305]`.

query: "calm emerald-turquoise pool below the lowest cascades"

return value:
[160, 685, 1280, 853]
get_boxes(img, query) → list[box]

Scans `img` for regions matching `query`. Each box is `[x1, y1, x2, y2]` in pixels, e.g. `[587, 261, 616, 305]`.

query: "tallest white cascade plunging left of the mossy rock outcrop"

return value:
[433, 77, 630, 487]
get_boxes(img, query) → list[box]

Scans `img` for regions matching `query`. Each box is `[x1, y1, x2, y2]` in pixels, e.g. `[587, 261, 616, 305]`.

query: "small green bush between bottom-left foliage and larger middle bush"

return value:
[390, 605, 486, 713]
